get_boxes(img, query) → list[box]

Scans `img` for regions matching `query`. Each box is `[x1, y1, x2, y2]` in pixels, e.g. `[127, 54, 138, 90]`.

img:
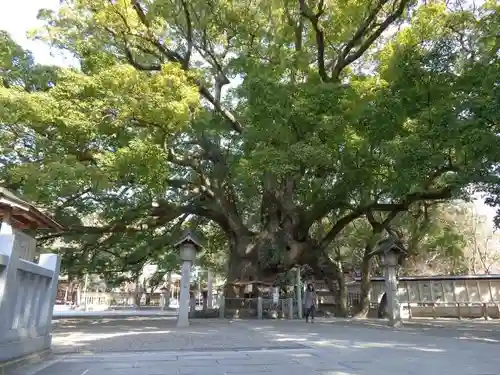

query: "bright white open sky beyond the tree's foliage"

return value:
[0, 0, 495, 226]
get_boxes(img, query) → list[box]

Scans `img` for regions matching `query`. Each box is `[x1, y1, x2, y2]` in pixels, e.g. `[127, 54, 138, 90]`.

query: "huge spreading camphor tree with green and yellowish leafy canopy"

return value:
[0, 0, 500, 312]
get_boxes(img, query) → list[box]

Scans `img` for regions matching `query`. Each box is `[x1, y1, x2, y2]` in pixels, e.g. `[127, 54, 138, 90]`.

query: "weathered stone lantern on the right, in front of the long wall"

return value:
[372, 235, 408, 327]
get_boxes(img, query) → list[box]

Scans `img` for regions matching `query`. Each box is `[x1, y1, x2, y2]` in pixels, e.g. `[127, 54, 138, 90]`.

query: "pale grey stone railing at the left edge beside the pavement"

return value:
[0, 223, 60, 362]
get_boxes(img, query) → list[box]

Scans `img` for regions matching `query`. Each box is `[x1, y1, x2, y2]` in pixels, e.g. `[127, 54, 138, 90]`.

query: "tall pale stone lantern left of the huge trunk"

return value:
[174, 230, 202, 327]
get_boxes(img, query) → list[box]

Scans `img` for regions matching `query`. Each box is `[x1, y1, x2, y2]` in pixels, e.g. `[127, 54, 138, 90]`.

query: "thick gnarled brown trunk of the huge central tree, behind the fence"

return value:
[219, 198, 359, 316]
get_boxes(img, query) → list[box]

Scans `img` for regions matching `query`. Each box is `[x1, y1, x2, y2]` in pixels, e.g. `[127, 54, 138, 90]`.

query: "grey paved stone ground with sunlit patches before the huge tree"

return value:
[9, 317, 500, 375]
